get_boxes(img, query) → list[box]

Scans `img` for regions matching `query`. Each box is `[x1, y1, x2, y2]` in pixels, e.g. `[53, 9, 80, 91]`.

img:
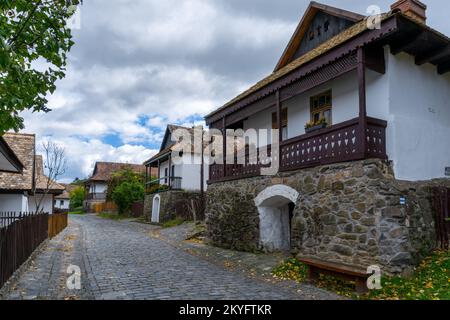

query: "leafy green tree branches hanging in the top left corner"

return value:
[0, 0, 80, 136]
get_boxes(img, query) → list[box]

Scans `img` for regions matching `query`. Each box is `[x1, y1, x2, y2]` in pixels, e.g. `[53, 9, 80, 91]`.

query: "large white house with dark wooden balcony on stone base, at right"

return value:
[206, 0, 450, 273]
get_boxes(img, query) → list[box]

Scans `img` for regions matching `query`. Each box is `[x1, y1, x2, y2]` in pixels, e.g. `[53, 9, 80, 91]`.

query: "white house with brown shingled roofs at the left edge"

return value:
[0, 133, 64, 214]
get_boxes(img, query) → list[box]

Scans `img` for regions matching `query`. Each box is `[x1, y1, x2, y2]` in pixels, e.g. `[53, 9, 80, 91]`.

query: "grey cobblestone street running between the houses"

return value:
[2, 215, 339, 300]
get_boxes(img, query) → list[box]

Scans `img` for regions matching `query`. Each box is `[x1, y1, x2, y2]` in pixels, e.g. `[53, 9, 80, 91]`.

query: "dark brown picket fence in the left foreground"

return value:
[0, 212, 48, 288]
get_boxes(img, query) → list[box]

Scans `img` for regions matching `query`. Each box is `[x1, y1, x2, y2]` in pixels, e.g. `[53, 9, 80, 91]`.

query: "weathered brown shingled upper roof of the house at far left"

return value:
[0, 133, 36, 191]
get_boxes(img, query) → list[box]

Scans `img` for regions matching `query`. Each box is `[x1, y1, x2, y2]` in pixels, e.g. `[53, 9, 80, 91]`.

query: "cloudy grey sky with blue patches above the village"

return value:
[24, 0, 450, 182]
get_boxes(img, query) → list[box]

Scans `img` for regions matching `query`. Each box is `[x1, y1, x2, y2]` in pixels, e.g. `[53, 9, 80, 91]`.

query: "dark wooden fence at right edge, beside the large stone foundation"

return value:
[433, 187, 450, 249]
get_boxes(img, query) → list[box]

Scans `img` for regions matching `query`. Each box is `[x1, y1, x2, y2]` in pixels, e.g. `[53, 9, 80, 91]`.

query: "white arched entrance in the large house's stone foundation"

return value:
[255, 185, 299, 251]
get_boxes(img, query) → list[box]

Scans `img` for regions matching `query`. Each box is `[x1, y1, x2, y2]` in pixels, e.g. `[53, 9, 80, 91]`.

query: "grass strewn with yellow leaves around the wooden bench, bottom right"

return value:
[272, 251, 450, 300]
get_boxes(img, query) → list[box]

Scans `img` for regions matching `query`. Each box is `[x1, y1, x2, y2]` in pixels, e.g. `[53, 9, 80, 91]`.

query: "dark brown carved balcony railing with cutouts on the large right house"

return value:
[210, 118, 387, 182]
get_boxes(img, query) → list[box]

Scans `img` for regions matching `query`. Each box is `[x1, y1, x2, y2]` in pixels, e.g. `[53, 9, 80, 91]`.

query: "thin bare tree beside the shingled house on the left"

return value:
[33, 140, 67, 212]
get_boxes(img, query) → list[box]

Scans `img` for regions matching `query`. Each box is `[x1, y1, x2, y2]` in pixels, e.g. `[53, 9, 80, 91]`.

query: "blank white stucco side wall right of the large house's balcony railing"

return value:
[387, 49, 450, 180]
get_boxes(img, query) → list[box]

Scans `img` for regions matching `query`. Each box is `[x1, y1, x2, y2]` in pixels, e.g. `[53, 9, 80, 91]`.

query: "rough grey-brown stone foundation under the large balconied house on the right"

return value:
[206, 160, 450, 273]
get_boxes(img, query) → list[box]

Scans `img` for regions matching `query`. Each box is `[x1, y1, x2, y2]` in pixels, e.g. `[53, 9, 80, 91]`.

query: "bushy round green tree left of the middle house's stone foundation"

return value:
[112, 181, 144, 215]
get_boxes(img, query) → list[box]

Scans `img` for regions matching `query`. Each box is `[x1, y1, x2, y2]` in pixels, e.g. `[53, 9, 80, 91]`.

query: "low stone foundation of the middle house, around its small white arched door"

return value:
[144, 191, 204, 223]
